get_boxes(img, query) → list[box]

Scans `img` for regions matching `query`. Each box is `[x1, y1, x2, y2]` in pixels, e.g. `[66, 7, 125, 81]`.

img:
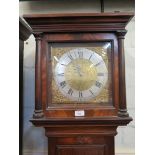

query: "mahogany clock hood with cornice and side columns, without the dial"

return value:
[24, 13, 133, 118]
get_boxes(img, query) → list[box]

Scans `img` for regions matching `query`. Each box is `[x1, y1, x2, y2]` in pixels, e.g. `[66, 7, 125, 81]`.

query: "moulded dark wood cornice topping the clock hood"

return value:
[23, 12, 134, 33]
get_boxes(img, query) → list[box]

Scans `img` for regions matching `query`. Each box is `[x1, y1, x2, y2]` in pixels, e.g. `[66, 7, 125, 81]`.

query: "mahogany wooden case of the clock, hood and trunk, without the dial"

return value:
[24, 13, 134, 155]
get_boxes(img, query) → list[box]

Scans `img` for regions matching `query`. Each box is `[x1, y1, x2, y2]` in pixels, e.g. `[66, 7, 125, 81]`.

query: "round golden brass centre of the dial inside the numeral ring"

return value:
[65, 59, 97, 91]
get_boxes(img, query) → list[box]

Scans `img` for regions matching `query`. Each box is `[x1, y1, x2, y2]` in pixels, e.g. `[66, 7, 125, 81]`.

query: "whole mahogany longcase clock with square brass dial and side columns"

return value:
[24, 13, 133, 155]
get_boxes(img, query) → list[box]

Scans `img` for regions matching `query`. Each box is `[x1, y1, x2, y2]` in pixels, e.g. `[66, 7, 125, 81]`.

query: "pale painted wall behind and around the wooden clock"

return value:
[19, 0, 135, 155]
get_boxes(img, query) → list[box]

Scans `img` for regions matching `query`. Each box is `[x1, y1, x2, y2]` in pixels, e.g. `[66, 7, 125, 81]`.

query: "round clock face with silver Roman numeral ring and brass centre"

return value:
[54, 47, 108, 102]
